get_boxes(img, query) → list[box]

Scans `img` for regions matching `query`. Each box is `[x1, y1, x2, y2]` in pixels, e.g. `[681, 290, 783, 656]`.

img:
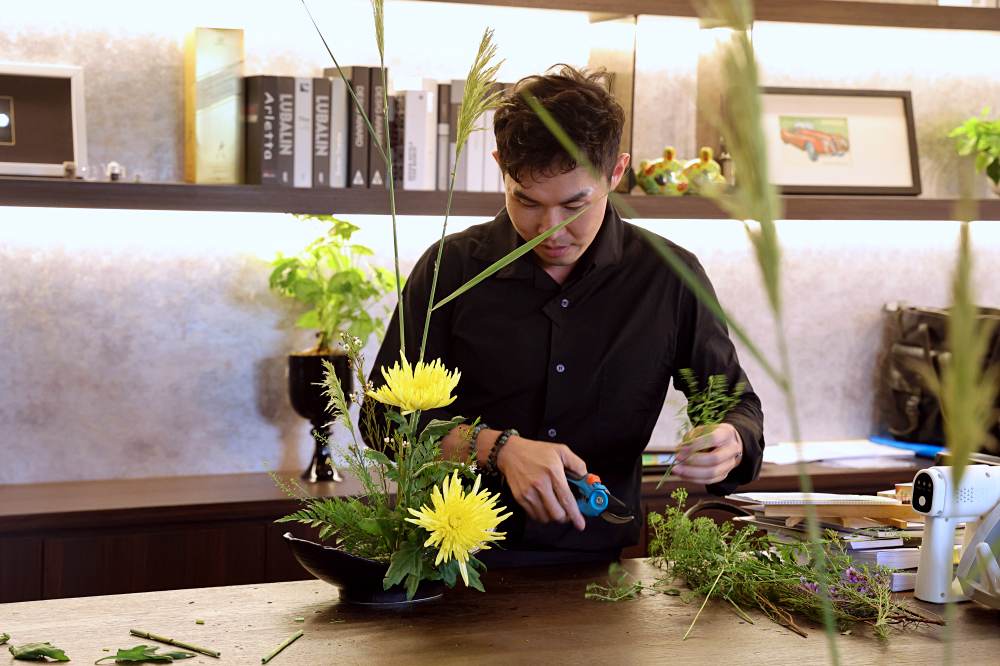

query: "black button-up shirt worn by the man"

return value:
[371, 204, 764, 552]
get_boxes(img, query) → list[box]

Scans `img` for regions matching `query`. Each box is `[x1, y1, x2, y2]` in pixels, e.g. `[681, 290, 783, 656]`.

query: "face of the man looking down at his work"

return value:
[504, 154, 628, 275]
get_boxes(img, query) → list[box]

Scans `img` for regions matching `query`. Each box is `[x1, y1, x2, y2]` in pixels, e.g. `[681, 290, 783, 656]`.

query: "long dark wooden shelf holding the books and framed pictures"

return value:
[0, 178, 1000, 220]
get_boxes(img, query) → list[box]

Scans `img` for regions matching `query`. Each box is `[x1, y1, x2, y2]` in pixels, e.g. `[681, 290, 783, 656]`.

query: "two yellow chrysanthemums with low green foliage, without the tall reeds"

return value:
[275, 336, 510, 598]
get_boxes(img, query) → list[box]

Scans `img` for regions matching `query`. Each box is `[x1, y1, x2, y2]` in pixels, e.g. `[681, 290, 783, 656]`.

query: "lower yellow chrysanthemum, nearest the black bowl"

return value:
[406, 470, 511, 585]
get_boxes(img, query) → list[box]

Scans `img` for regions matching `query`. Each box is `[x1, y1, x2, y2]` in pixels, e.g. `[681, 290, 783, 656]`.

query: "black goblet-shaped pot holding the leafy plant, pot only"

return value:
[288, 354, 354, 481]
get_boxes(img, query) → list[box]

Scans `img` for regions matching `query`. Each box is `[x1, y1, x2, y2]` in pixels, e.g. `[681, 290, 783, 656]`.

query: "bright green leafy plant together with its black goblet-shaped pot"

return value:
[269, 215, 396, 481]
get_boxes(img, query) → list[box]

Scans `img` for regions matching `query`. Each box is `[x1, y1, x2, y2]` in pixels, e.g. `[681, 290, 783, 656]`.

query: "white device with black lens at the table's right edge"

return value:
[911, 465, 1000, 608]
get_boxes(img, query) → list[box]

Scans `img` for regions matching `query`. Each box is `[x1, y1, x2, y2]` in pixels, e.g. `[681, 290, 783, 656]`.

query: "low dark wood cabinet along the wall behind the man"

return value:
[0, 463, 929, 602]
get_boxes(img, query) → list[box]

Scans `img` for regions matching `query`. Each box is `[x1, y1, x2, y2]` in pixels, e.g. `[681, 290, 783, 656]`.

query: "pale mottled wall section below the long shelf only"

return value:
[0, 208, 1000, 483]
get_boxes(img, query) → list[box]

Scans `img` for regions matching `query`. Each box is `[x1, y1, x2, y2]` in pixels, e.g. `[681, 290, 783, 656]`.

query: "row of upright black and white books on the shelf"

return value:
[244, 66, 503, 192]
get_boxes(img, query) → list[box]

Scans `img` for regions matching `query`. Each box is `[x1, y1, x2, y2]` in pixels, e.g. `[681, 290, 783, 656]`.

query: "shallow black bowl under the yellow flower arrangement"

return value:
[284, 532, 444, 606]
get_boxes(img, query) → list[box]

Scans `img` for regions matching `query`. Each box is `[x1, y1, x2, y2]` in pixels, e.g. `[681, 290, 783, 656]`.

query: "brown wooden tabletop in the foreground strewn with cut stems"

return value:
[0, 560, 1000, 666]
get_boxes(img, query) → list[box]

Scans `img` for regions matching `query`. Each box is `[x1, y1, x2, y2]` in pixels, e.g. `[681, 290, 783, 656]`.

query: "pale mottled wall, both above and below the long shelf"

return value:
[0, 0, 1000, 483]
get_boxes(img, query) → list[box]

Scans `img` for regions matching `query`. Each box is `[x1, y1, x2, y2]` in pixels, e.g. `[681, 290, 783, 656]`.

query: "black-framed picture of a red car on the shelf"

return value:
[761, 88, 920, 195]
